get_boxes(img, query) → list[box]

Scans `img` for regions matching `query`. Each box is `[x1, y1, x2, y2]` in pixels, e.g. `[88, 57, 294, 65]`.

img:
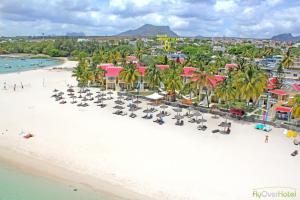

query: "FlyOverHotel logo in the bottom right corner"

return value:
[252, 187, 297, 200]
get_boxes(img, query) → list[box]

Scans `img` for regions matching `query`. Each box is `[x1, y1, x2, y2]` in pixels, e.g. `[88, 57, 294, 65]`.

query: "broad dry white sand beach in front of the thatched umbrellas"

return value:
[0, 61, 300, 200]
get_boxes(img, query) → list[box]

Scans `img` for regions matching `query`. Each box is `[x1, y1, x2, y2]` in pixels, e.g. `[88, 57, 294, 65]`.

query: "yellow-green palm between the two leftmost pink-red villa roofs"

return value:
[119, 63, 140, 89]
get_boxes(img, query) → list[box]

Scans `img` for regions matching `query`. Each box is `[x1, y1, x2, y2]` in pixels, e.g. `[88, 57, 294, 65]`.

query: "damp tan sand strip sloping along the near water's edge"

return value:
[0, 146, 151, 200]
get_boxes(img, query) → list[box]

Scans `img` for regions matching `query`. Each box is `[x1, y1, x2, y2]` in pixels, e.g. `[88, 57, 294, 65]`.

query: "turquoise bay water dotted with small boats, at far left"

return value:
[0, 57, 61, 74]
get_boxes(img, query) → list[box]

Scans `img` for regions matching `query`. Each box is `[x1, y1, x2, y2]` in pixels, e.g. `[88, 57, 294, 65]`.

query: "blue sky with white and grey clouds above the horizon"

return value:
[0, 0, 300, 38]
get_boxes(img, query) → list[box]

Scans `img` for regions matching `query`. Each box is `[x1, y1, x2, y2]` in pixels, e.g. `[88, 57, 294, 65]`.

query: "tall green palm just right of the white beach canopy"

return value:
[163, 61, 183, 101]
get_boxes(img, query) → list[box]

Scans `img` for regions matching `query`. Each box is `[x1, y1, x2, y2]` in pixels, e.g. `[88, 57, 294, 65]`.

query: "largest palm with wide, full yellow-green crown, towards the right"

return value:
[233, 65, 267, 103]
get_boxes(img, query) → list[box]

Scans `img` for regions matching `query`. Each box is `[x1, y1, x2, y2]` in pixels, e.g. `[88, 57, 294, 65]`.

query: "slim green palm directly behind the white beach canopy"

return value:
[145, 64, 162, 89]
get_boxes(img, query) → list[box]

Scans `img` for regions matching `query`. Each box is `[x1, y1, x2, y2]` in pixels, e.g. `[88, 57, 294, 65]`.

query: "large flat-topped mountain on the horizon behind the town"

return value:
[117, 24, 178, 37]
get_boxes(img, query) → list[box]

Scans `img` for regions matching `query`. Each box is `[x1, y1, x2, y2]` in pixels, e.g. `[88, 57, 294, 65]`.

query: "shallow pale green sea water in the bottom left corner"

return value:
[0, 162, 119, 200]
